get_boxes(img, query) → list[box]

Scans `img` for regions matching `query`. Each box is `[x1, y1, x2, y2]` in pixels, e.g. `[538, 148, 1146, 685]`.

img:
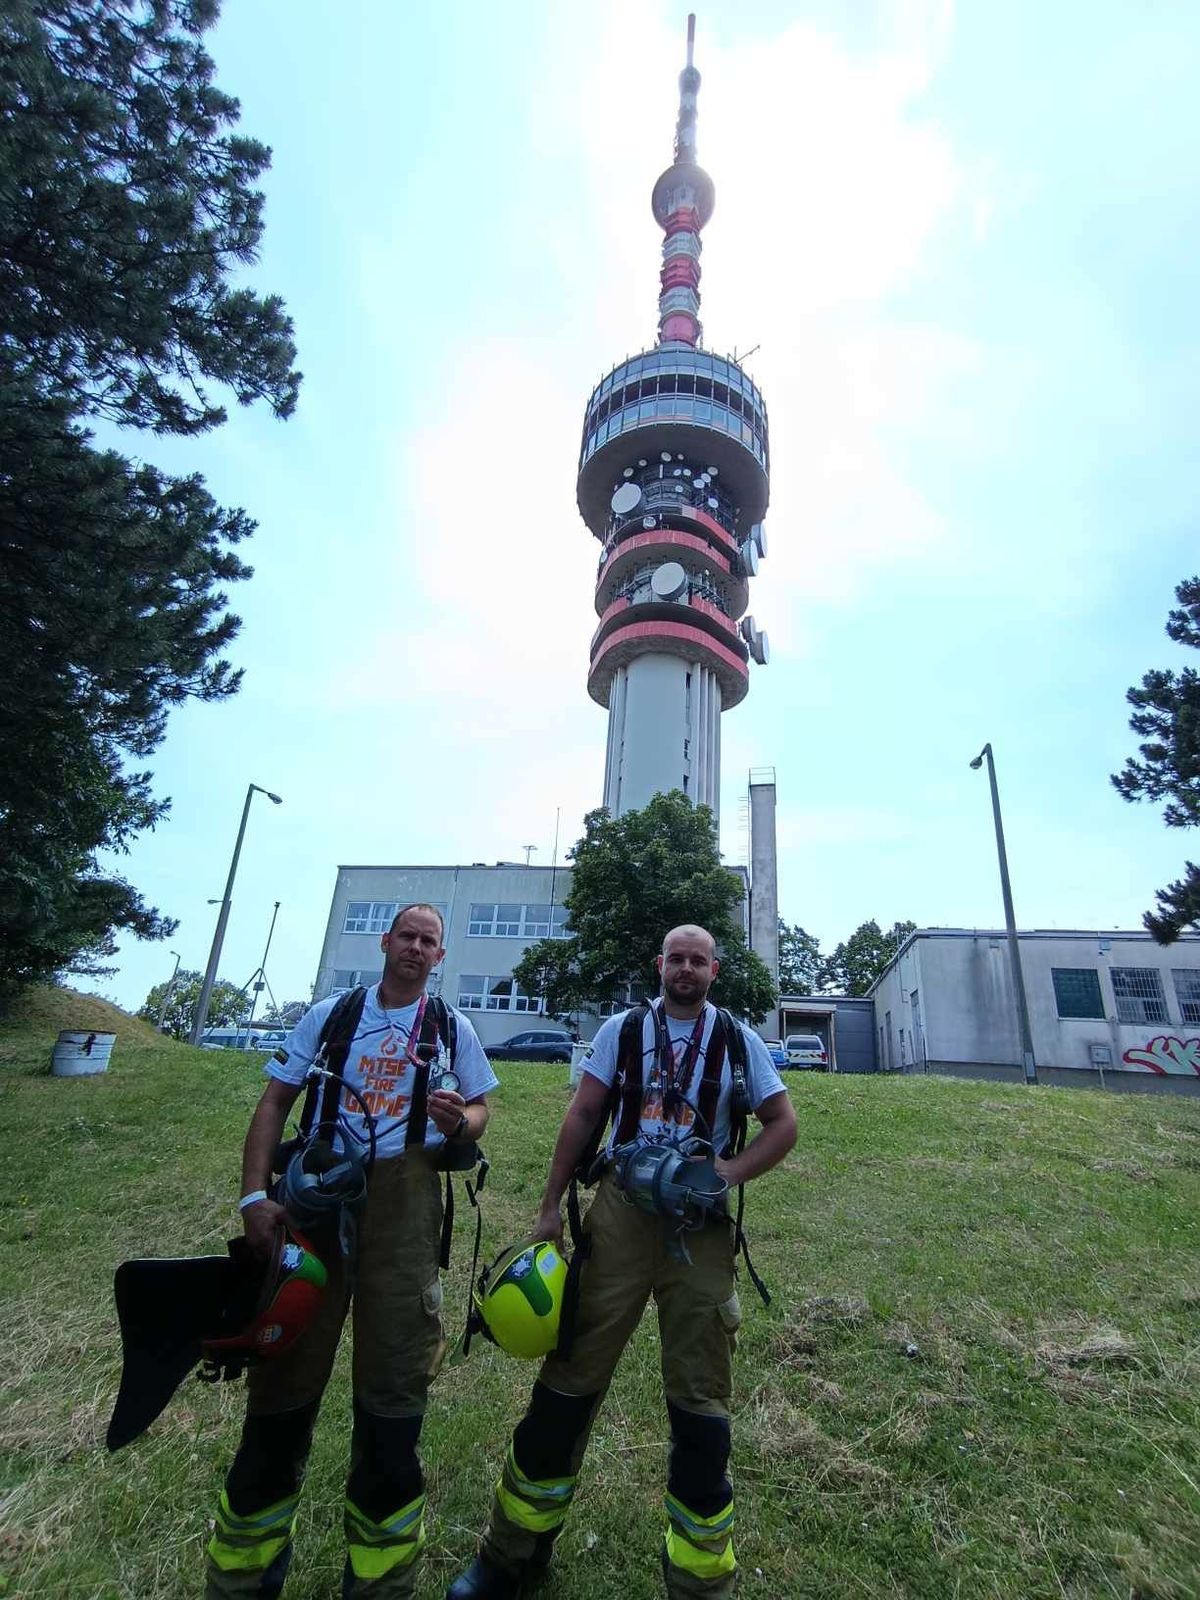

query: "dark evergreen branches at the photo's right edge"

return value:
[1112, 578, 1200, 944]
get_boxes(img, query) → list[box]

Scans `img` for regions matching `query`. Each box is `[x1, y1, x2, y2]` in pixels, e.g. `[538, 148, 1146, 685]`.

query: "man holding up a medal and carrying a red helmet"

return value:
[205, 904, 496, 1600]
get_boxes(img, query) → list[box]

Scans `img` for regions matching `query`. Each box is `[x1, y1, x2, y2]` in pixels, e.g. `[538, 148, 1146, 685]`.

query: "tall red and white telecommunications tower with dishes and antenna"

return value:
[576, 16, 770, 816]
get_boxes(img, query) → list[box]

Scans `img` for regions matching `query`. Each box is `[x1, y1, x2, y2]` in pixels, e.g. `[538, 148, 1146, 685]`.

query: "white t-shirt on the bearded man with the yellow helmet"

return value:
[584, 1002, 784, 1154]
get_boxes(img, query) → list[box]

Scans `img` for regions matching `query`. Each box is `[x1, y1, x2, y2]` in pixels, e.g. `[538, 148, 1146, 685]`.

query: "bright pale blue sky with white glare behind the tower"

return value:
[99, 0, 1200, 1006]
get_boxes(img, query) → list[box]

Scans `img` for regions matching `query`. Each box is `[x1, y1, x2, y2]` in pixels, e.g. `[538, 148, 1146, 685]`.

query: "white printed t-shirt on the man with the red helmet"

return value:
[266, 984, 499, 1155]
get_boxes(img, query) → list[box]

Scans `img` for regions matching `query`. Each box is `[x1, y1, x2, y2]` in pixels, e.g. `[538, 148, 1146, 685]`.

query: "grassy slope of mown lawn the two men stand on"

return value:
[0, 992, 1200, 1600]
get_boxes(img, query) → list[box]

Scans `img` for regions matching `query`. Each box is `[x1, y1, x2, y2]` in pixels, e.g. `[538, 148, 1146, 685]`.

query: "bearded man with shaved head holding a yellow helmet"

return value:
[446, 925, 795, 1600]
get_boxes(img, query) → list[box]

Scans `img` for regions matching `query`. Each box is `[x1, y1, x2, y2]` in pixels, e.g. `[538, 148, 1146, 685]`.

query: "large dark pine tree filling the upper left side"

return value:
[0, 0, 299, 992]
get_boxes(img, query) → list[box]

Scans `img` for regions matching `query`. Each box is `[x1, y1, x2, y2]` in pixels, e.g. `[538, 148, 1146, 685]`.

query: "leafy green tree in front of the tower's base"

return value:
[514, 790, 774, 1019]
